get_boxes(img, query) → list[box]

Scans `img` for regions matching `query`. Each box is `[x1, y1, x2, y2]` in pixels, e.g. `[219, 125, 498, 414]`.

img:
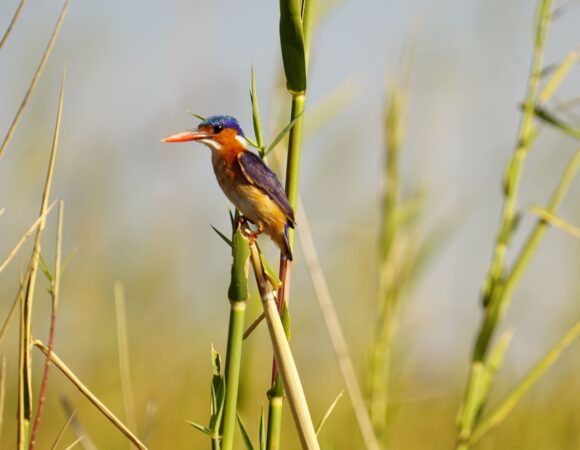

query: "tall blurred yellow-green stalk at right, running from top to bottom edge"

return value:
[457, 0, 566, 442]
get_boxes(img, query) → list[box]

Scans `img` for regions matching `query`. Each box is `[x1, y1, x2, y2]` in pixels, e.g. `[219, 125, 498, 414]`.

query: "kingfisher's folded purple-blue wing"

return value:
[238, 152, 296, 228]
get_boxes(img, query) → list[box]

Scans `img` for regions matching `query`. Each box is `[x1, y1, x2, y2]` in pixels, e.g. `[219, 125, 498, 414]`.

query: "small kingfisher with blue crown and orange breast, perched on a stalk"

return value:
[162, 116, 296, 260]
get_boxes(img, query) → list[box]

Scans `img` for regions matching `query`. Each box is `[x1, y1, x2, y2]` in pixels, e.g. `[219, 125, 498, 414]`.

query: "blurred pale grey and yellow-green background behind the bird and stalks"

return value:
[0, 0, 580, 449]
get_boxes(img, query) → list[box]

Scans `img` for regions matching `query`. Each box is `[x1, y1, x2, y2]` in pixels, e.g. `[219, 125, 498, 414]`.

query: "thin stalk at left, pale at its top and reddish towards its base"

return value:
[28, 200, 63, 450]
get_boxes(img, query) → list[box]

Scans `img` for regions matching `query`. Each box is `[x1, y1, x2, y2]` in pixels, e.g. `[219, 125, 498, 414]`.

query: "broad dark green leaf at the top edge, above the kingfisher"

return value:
[280, 0, 306, 94]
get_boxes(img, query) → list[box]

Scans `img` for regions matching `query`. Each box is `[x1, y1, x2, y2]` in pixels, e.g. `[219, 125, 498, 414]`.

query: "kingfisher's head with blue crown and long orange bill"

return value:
[161, 116, 247, 151]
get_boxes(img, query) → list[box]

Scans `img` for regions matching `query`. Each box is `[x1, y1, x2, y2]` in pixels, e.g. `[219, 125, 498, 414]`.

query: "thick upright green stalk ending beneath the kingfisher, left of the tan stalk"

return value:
[220, 225, 250, 450]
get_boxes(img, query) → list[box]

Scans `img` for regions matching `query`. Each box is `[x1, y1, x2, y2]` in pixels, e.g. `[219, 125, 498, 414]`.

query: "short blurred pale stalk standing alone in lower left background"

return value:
[113, 281, 139, 435]
